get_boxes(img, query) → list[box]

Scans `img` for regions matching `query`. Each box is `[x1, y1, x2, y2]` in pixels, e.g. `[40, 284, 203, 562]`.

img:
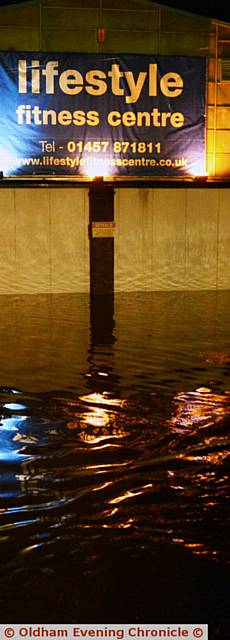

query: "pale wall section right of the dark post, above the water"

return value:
[115, 188, 230, 291]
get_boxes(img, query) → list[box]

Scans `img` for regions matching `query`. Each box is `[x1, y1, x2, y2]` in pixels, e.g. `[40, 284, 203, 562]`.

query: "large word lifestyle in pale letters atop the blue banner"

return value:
[18, 59, 184, 104]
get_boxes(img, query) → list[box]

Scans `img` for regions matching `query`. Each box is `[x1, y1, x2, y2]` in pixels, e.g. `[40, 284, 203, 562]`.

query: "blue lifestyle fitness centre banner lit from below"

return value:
[0, 52, 206, 178]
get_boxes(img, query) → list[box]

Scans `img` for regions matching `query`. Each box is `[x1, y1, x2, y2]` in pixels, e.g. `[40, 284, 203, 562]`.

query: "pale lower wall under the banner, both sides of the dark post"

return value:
[0, 188, 230, 294]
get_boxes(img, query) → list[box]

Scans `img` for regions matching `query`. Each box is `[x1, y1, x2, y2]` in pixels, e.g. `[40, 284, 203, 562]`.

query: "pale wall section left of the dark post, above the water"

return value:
[0, 188, 89, 294]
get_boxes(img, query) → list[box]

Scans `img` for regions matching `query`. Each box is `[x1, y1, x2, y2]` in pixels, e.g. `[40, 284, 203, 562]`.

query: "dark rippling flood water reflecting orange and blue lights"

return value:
[0, 292, 230, 640]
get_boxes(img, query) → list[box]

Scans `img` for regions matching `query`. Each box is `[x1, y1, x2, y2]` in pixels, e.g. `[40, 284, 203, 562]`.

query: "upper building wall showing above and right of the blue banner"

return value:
[0, 0, 230, 178]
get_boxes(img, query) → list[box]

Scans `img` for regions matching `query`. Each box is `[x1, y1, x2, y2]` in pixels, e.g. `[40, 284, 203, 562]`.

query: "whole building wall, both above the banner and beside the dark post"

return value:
[0, 0, 230, 294]
